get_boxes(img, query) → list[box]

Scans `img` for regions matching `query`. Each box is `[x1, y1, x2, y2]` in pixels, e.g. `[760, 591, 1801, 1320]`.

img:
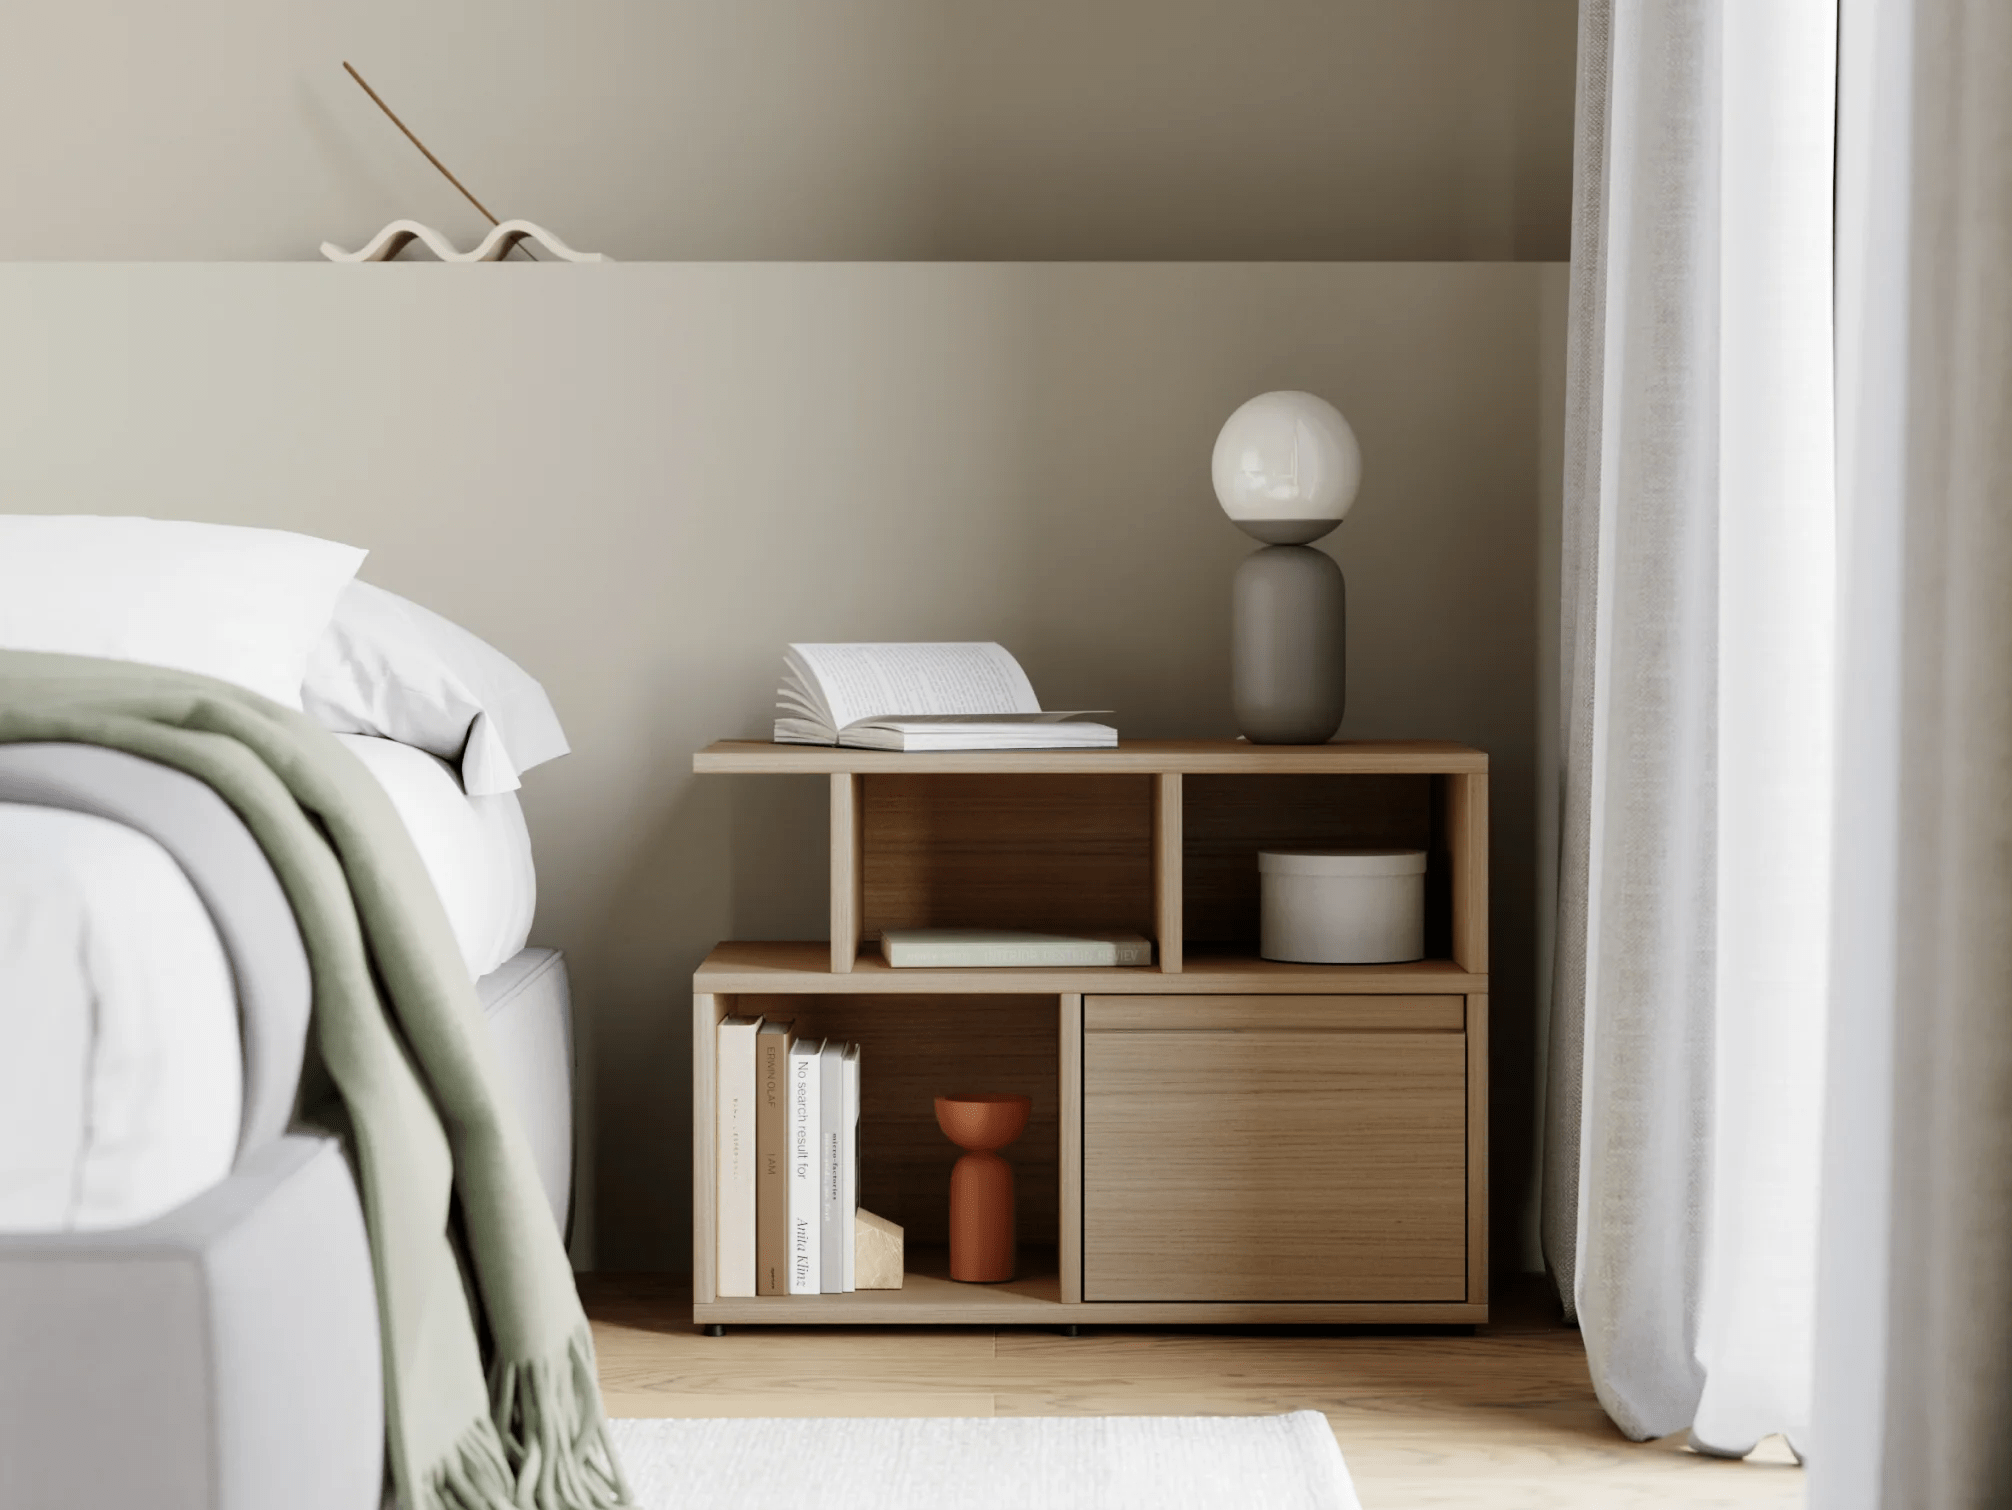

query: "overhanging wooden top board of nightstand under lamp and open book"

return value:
[692, 739, 1489, 775]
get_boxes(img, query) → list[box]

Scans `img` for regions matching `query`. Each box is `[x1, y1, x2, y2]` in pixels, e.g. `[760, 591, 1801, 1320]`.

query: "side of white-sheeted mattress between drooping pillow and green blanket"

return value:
[336, 735, 537, 980]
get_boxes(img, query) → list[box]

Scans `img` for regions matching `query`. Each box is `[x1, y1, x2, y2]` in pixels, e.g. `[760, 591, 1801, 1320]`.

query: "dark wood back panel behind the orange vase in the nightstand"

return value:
[738, 995, 1060, 1248]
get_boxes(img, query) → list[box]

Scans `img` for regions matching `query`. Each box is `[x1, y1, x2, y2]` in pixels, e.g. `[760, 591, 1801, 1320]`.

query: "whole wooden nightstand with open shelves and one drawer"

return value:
[692, 741, 1489, 1325]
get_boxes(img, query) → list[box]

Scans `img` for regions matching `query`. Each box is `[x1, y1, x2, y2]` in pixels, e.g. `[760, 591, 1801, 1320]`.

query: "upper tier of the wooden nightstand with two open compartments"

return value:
[776, 743, 1489, 974]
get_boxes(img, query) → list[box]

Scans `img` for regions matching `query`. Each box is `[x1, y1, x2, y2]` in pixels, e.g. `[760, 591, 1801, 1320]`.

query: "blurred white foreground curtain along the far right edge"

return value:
[1809, 0, 2012, 1510]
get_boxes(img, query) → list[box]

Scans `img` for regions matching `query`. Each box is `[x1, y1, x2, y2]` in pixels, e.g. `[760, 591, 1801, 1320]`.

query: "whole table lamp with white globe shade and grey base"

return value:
[1209, 391, 1362, 745]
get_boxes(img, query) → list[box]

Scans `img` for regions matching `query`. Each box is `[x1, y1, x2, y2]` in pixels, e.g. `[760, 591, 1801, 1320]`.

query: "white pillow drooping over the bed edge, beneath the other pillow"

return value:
[300, 582, 569, 797]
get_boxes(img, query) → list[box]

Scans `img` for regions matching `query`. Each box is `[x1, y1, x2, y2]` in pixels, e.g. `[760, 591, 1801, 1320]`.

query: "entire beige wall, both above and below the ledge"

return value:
[0, 0, 1577, 1268]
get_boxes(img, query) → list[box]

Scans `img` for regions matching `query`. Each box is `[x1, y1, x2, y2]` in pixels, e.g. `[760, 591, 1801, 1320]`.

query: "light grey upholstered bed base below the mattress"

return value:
[0, 948, 571, 1510]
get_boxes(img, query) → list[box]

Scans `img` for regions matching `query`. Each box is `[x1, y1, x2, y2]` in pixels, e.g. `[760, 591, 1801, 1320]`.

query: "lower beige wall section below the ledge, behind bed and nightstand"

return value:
[0, 264, 1561, 1268]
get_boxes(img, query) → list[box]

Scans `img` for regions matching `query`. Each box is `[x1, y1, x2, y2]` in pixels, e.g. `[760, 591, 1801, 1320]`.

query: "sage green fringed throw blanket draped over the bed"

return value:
[0, 650, 630, 1510]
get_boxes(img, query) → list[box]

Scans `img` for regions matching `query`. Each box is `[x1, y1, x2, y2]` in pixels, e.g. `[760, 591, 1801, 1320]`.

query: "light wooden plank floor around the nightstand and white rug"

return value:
[581, 1274, 1803, 1510]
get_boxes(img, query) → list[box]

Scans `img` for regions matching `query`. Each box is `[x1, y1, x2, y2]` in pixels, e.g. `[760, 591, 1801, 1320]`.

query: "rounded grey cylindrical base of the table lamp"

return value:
[1229, 551, 1348, 745]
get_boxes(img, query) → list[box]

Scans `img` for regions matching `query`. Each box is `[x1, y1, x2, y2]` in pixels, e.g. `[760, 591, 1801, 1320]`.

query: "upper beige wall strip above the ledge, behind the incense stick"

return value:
[0, 0, 1575, 260]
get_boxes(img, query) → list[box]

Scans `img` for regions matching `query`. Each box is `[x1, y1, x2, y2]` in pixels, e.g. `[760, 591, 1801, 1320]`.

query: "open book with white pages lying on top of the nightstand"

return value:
[775, 644, 1119, 751]
